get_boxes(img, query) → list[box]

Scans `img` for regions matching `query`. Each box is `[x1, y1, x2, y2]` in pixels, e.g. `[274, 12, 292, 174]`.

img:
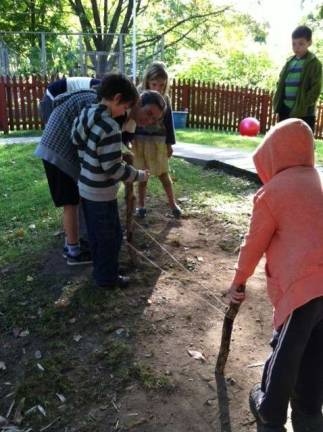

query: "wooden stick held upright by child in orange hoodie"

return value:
[215, 285, 246, 375]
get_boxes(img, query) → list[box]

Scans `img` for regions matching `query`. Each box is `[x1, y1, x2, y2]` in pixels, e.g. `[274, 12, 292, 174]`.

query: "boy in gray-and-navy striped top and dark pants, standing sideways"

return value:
[72, 73, 162, 288]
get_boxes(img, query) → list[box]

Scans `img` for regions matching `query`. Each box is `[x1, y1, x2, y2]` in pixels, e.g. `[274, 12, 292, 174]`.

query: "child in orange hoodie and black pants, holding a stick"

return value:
[230, 118, 323, 432]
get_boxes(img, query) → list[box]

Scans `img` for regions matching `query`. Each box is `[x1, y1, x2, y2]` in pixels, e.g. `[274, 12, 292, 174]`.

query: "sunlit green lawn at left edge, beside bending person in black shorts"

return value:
[0, 144, 61, 267]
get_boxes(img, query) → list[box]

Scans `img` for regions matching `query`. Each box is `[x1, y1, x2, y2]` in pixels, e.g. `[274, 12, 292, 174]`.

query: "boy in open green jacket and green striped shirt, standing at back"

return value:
[273, 26, 322, 132]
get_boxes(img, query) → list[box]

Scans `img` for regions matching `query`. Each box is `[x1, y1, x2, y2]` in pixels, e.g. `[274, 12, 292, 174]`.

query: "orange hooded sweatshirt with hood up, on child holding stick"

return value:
[234, 119, 323, 329]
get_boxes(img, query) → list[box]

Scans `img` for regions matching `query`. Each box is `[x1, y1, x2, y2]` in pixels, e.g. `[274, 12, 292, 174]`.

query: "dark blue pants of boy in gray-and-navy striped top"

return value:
[82, 198, 122, 286]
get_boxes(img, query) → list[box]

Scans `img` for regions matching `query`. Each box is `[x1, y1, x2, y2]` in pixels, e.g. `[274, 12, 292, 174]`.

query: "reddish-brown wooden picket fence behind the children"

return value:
[0, 76, 323, 139]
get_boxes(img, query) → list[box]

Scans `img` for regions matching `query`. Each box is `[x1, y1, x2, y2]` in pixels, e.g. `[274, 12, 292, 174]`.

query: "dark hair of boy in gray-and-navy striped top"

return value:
[97, 72, 139, 105]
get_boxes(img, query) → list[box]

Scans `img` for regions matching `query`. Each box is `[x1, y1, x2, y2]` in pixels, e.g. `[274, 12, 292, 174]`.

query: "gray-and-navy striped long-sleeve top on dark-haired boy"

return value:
[72, 104, 143, 201]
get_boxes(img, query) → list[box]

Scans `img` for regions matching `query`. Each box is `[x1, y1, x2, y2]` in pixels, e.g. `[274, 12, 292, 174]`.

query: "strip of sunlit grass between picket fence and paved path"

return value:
[176, 129, 323, 165]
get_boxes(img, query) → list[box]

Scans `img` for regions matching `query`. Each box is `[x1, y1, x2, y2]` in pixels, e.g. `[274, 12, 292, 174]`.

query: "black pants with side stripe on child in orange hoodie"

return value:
[259, 297, 323, 426]
